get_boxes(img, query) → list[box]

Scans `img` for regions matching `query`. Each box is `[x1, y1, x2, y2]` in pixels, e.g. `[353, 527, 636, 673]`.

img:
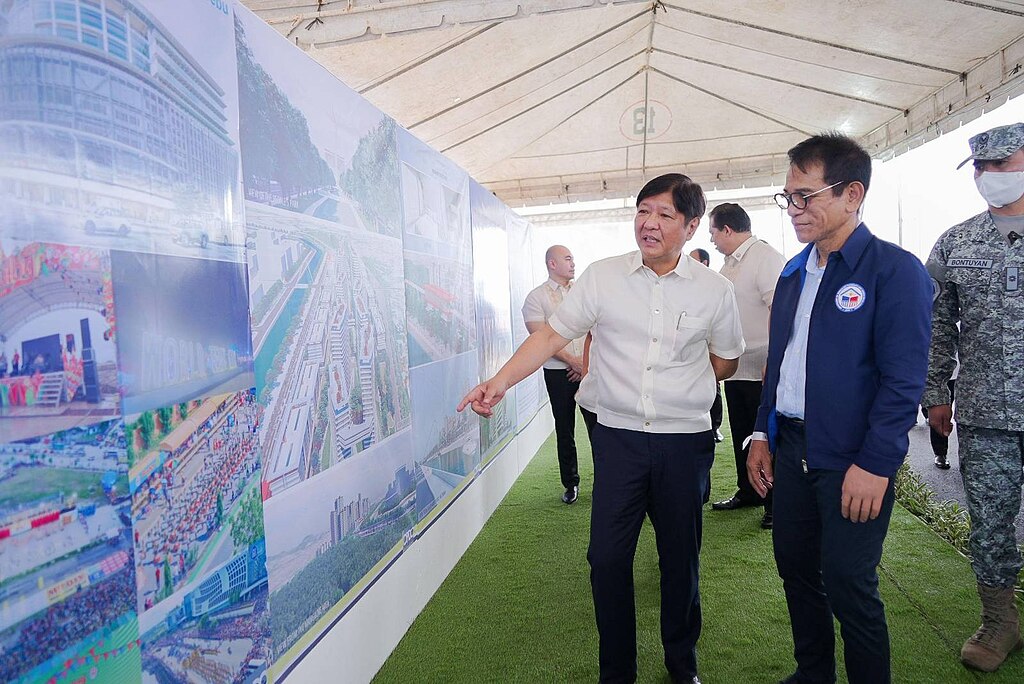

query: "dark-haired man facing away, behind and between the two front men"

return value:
[708, 202, 785, 529]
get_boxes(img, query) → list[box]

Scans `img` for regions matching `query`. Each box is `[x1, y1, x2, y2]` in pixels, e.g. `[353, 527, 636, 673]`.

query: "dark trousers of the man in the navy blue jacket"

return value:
[772, 417, 894, 684]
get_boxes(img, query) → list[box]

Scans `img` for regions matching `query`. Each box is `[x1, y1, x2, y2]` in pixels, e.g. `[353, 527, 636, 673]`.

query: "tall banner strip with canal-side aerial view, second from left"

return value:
[234, 3, 422, 670]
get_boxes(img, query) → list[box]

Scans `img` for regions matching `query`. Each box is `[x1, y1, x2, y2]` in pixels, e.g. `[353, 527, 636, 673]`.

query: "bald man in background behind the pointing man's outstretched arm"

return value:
[522, 245, 583, 504]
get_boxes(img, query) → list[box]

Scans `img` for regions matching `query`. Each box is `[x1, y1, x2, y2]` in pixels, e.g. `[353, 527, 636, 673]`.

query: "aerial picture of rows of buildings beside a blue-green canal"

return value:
[248, 199, 411, 498]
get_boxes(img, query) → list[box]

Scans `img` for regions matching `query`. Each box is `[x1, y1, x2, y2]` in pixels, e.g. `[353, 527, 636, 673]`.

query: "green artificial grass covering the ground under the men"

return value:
[374, 413, 1024, 684]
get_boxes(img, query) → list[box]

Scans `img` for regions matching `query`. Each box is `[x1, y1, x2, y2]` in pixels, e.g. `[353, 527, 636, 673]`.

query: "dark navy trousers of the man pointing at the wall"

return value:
[587, 423, 715, 682]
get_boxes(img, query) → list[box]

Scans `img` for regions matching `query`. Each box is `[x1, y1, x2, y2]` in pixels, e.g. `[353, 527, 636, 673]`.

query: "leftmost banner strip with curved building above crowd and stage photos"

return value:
[0, 0, 270, 684]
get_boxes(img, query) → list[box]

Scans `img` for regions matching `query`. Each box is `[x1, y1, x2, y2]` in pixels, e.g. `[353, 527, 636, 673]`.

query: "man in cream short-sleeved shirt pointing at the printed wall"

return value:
[459, 174, 743, 683]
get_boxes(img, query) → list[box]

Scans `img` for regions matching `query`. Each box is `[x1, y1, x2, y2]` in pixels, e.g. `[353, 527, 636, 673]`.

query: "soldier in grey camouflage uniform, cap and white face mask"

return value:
[922, 123, 1024, 672]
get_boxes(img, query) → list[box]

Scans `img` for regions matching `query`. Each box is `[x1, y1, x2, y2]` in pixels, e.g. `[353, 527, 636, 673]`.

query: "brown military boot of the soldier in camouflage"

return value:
[961, 584, 1024, 672]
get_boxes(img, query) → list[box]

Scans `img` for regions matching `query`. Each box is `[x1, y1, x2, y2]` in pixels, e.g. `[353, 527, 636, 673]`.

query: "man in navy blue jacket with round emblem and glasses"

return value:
[746, 133, 932, 684]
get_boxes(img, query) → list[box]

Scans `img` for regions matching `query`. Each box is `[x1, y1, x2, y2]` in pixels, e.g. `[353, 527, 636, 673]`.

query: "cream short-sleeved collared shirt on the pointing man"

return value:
[548, 251, 743, 433]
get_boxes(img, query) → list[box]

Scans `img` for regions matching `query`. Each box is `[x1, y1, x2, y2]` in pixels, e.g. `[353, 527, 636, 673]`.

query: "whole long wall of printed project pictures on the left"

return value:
[0, 0, 540, 684]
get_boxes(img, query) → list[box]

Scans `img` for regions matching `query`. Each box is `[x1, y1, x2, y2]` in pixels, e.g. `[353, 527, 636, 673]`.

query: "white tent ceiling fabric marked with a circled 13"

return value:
[245, 0, 1024, 205]
